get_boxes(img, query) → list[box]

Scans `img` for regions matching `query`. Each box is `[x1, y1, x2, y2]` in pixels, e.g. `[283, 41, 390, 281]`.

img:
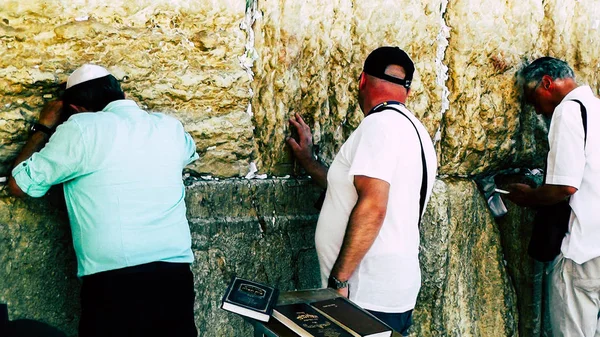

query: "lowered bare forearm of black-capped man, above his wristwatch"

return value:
[331, 199, 385, 280]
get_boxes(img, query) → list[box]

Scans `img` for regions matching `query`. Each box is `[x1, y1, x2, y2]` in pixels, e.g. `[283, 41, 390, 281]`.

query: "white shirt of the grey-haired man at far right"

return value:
[546, 86, 600, 264]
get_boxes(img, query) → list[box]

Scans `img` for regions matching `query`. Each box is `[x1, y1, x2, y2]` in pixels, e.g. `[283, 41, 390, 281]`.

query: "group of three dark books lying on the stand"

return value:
[221, 278, 392, 337]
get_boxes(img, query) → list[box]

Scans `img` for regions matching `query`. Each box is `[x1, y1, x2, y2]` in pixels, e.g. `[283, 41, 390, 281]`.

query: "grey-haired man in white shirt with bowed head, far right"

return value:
[507, 57, 600, 337]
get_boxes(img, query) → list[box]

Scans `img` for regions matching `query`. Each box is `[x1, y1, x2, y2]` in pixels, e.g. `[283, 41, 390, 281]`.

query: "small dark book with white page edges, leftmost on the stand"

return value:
[221, 277, 279, 322]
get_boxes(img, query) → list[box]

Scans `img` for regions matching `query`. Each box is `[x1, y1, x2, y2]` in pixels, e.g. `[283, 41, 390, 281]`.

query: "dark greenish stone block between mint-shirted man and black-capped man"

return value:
[186, 180, 320, 337]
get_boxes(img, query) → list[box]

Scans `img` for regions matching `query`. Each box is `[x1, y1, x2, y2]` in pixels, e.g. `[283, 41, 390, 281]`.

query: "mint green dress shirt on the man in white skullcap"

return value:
[12, 100, 198, 276]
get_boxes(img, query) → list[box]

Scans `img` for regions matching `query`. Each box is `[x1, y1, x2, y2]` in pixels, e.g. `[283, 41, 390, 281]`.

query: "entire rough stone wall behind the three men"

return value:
[0, 0, 600, 336]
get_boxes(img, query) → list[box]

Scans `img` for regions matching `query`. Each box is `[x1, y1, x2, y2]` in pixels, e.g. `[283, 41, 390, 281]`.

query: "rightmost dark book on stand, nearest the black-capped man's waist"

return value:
[310, 297, 392, 337]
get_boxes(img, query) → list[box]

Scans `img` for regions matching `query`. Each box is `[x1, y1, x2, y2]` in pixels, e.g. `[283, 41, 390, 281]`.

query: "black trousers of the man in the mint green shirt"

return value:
[79, 262, 198, 337]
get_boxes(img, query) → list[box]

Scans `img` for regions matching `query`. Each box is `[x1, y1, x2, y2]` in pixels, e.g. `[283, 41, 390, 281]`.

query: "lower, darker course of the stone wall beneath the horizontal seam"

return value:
[0, 179, 517, 337]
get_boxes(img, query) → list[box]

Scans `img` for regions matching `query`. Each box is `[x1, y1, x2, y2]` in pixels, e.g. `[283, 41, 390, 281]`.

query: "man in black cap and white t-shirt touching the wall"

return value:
[287, 47, 437, 335]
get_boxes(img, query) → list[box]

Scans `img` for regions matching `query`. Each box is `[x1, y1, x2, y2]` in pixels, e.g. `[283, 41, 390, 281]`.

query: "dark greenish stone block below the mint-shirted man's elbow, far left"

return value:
[0, 190, 79, 336]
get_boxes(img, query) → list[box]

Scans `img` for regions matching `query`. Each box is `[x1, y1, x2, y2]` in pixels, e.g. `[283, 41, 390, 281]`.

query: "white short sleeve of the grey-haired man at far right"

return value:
[546, 102, 585, 189]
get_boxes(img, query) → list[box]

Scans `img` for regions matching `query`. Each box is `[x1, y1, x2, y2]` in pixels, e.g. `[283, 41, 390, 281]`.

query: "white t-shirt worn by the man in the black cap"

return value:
[315, 105, 437, 313]
